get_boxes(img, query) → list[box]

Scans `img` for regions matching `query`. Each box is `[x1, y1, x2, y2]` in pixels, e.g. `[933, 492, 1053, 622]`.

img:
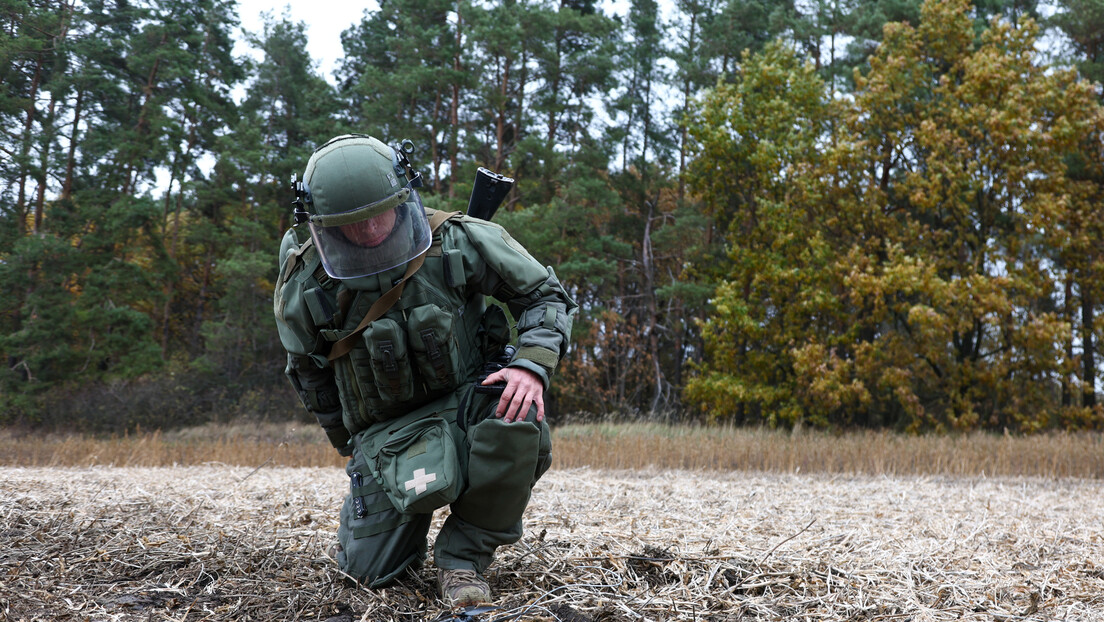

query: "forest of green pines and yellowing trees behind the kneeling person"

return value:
[0, 0, 1104, 434]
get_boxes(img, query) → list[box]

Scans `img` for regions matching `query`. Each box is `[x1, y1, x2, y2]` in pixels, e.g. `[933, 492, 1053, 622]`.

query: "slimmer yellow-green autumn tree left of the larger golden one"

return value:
[687, 43, 830, 423]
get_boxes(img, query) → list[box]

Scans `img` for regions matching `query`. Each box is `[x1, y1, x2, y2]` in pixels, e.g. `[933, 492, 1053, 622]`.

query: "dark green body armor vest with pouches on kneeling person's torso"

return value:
[276, 212, 510, 433]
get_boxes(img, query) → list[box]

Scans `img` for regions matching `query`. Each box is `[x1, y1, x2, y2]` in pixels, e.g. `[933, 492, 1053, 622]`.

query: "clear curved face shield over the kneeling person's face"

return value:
[310, 185, 432, 278]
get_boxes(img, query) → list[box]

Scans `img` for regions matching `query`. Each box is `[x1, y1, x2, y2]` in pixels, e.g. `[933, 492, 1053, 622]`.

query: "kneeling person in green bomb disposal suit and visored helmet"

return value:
[274, 135, 576, 587]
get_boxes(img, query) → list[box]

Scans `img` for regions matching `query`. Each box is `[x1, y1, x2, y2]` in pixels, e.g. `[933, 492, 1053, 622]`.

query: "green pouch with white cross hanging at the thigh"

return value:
[364, 417, 464, 514]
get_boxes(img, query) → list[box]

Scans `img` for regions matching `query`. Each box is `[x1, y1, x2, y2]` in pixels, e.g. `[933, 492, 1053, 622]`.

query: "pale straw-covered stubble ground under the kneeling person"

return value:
[0, 465, 1104, 622]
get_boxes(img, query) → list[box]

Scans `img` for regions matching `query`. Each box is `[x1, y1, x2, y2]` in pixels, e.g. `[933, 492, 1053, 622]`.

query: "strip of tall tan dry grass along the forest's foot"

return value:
[0, 421, 1104, 479]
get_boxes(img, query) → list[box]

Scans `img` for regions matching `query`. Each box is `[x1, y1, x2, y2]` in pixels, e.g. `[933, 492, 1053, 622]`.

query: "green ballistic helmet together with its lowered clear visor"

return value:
[302, 134, 432, 278]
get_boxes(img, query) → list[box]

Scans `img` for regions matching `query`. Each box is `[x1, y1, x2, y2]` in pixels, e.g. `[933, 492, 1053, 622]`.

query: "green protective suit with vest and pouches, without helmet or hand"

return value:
[274, 209, 576, 587]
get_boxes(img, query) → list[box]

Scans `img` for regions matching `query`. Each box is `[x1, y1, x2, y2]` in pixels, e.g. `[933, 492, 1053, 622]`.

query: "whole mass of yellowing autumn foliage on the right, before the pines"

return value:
[689, 1, 1100, 432]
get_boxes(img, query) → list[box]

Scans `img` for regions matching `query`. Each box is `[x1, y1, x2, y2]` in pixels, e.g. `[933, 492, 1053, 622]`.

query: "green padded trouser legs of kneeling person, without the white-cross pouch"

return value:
[338, 388, 552, 588]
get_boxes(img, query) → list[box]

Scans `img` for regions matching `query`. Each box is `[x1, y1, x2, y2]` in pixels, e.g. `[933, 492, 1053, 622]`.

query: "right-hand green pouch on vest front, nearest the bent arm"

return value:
[406, 305, 460, 391]
